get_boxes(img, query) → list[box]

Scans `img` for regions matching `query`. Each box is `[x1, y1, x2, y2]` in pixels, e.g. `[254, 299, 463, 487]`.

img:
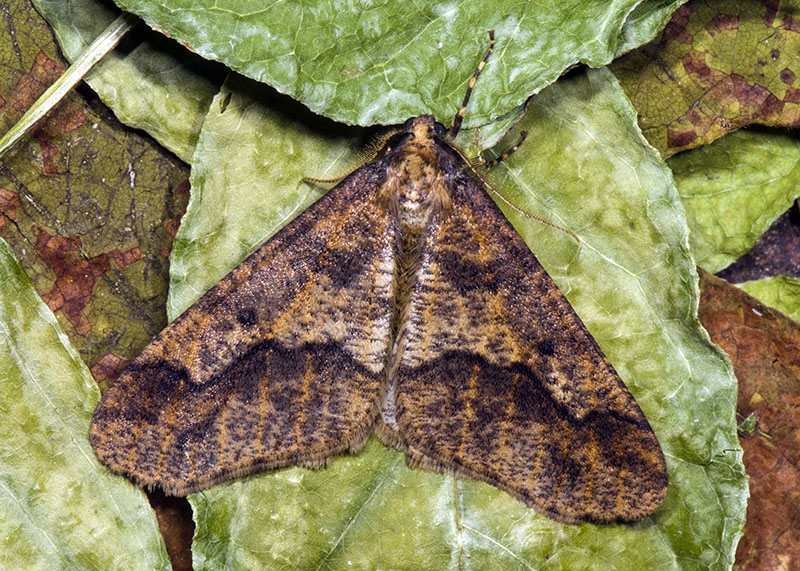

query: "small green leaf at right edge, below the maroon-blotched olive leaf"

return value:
[669, 127, 800, 273]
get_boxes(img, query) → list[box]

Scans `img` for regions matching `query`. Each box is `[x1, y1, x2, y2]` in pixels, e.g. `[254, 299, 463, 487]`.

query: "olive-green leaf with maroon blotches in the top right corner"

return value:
[611, 0, 800, 157]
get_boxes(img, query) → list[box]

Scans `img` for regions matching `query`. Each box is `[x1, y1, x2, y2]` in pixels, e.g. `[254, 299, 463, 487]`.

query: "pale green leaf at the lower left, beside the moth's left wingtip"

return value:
[0, 240, 169, 569]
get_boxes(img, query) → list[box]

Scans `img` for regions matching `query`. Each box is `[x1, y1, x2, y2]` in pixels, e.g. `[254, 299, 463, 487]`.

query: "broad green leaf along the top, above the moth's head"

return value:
[106, 0, 675, 126]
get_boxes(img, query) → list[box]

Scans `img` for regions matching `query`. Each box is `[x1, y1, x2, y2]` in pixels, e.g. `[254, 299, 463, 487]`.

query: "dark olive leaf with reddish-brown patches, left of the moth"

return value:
[0, 0, 188, 381]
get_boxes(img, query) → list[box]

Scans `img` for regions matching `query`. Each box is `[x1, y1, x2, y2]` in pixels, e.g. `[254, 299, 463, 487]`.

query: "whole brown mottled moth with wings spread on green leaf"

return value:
[91, 32, 667, 523]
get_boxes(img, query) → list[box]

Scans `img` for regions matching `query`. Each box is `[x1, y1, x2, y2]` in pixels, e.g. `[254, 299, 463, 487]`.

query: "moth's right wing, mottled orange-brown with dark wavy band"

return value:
[394, 172, 667, 523]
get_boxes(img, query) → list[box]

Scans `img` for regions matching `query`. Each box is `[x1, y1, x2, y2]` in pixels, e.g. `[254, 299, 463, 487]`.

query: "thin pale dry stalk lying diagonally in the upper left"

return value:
[0, 12, 139, 157]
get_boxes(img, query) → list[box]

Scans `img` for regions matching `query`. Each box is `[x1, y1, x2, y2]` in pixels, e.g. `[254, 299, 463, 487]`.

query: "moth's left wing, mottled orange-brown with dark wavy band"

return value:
[91, 163, 397, 495]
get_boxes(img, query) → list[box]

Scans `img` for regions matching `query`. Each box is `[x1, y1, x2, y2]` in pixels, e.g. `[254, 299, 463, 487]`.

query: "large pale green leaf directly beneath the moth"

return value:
[170, 70, 747, 569]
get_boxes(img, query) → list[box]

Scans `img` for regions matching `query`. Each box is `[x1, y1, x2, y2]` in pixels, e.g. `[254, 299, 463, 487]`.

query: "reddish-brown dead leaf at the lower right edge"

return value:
[699, 270, 800, 570]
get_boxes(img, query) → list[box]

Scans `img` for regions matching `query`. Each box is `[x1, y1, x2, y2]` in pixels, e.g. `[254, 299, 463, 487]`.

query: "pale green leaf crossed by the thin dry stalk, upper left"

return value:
[31, 0, 224, 161]
